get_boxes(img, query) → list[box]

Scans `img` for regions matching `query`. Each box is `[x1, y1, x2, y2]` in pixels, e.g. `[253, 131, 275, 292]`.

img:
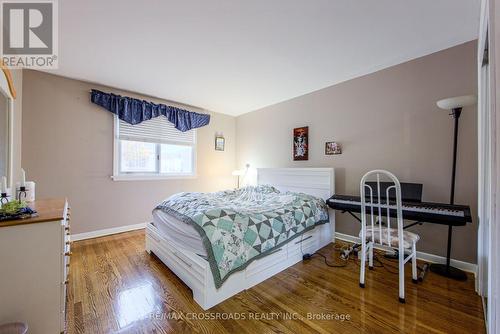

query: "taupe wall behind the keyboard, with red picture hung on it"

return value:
[236, 42, 477, 263]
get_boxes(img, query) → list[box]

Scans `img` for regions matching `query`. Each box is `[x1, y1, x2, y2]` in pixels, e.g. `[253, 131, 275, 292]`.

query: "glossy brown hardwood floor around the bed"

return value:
[67, 231, 485, 334]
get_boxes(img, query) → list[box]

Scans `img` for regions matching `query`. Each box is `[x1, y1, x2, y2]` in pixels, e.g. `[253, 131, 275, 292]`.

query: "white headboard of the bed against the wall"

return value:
[257, 168, 335, 200]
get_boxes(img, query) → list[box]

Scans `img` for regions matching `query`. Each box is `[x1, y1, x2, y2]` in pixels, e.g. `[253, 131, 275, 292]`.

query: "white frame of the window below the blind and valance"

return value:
[111, 115, 198, 181]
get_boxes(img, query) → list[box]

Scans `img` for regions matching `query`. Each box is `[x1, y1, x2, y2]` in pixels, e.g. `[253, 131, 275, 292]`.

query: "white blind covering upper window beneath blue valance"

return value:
[118, 116, 196, 145]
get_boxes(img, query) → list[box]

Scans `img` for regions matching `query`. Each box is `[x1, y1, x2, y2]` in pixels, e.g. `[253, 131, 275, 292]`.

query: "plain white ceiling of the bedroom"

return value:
[49, 0, 480, 115]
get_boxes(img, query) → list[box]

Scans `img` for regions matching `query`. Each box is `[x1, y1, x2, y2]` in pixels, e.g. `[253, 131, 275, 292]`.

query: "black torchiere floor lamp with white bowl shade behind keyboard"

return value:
[430, 95, 476, 281]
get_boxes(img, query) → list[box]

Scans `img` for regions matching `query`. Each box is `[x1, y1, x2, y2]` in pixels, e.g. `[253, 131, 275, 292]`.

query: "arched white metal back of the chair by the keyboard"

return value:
[360, 169, 404, 249]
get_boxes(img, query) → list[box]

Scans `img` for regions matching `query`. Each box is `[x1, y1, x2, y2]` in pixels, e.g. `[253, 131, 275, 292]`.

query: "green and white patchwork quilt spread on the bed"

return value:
[156, 185, 329, 288]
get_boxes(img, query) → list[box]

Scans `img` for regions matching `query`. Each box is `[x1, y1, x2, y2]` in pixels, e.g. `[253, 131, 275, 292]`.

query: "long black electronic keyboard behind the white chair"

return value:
[327, 195, 472, 226]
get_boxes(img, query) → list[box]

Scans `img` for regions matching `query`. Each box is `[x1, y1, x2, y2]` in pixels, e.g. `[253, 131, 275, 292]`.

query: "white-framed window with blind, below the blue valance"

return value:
[113, 116, 196, 180]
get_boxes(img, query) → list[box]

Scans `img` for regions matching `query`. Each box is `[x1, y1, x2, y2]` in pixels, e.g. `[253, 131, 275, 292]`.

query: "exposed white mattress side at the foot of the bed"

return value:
[153, 210, 207, 257]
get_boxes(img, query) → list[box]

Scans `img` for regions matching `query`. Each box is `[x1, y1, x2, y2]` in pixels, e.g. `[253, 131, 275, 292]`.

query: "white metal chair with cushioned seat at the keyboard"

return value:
[359, 170, 420, 303]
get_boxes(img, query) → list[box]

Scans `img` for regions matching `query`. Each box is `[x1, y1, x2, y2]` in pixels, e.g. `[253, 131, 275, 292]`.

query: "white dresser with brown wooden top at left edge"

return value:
[0, 199, 71, 334]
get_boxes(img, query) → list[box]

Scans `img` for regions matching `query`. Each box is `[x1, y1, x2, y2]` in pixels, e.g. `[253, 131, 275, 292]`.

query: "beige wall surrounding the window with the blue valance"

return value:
[22, 71, 236, 233]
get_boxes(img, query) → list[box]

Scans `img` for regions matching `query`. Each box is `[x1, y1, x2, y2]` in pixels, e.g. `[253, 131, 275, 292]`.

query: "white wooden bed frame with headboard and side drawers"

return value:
[146, 168, 335, 310]
